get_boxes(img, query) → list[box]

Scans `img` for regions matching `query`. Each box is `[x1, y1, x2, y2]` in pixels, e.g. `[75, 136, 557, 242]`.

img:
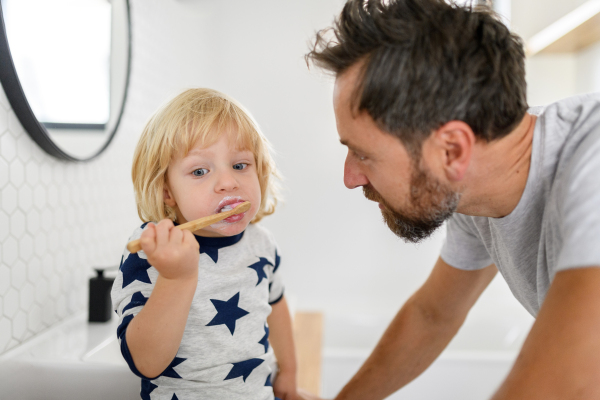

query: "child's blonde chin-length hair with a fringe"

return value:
[131, 88, 280, 223]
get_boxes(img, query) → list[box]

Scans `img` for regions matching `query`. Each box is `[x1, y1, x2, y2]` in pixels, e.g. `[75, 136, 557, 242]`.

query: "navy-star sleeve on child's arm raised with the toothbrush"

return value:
[111, 226, 158, 379]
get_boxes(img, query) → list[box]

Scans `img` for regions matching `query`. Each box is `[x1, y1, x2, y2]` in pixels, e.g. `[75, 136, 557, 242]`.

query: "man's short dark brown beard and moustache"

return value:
[363, 163, 460, 243]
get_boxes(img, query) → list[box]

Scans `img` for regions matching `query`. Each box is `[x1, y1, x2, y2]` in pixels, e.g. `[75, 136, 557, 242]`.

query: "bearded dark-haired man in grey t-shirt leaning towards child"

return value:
[305, 0, 600, 400]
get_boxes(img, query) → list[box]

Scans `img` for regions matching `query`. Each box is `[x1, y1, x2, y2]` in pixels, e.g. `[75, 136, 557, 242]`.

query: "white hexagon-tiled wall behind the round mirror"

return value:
[0, 1, 179, 354]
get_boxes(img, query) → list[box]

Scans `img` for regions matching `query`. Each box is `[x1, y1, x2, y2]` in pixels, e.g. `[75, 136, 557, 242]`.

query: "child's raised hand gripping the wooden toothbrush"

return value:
[140, 219, 200, 280]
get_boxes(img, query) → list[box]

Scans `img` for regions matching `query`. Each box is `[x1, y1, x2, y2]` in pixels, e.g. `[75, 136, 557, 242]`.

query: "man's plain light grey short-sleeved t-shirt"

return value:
[441, 93, 600, 316]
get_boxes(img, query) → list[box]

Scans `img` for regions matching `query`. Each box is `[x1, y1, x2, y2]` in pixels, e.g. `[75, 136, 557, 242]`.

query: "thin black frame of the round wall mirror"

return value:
[0, 0, 132, 161]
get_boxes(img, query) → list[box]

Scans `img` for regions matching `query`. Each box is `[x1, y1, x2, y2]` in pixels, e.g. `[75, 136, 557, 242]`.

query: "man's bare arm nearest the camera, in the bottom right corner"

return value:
[493, 267, 600, 400]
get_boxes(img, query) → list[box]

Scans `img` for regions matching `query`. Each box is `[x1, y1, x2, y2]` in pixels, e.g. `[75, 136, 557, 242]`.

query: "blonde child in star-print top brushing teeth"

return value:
[112, 89, 297, 400]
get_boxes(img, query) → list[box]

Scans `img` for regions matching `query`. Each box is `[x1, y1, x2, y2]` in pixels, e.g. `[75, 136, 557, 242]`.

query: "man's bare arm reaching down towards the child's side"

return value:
[336, 258, 497, 400]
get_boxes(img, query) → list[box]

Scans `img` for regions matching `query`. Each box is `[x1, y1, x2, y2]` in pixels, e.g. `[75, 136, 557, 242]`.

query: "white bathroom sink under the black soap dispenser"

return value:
[0, 313, 140, 400]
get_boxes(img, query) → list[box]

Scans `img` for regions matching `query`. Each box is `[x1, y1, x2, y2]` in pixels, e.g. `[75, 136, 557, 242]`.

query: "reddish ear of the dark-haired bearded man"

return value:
[433, 121, 476, 182]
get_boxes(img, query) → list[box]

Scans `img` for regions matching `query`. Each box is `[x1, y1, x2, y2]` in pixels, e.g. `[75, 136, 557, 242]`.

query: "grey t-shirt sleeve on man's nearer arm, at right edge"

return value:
[552, 127, 600, 273]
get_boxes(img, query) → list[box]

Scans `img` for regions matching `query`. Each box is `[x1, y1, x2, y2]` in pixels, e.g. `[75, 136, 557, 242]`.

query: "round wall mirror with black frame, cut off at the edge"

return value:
[0, 0, 131, 161]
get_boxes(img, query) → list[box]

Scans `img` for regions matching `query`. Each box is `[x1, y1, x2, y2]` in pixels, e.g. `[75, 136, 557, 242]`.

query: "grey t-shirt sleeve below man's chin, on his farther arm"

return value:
[441, 213, 493, 271]
